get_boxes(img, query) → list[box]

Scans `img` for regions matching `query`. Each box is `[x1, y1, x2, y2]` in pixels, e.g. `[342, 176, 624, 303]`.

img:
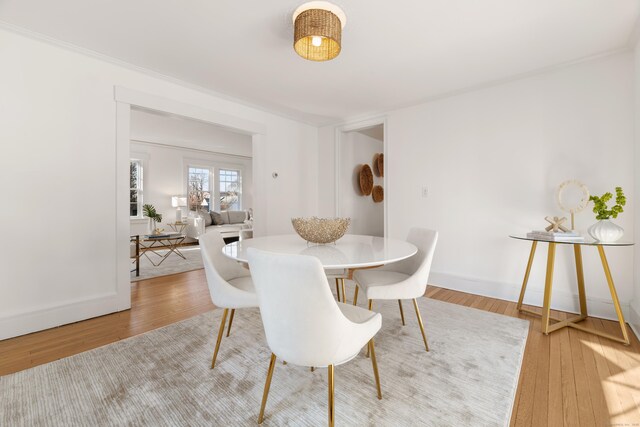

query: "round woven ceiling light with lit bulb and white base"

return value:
[293, 2, 346, 61]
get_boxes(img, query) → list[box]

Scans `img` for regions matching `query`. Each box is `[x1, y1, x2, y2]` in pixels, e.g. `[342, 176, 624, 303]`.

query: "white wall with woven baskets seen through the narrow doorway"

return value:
[339, 132, 384, 236]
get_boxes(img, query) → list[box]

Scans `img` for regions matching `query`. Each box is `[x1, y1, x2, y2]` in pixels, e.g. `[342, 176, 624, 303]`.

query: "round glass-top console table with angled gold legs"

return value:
[509, 234, 633, 345]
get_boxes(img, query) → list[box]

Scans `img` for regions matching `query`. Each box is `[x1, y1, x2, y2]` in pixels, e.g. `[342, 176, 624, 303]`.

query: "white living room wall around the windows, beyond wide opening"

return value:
[131, 141, 253, 235]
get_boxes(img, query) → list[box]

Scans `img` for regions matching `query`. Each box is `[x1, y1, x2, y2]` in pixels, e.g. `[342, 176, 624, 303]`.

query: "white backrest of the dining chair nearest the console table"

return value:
[384, 227, 438, 292]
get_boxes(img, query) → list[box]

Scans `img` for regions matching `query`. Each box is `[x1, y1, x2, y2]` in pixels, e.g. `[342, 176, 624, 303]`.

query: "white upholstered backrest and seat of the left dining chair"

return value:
[198, 230, 256, 308]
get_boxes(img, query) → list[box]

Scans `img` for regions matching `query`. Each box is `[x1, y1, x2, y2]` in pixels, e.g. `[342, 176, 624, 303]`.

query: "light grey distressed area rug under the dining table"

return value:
[0, 298, 529, 427]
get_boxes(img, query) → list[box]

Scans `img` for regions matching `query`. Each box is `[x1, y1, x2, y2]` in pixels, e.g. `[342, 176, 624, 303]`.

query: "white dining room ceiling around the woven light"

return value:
[0, 0, 640, 123]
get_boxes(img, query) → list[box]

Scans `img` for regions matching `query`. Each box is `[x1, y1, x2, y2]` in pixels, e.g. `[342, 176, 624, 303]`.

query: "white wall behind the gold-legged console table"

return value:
[319, 53, 634, 316]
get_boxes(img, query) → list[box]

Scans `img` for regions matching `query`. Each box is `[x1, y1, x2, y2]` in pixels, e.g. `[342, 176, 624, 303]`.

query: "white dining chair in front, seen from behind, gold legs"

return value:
[247, 248, 382, 426]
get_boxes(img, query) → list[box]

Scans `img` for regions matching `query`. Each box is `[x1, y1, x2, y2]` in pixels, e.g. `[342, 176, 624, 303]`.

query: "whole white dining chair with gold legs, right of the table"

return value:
[353, 228, 438, 351]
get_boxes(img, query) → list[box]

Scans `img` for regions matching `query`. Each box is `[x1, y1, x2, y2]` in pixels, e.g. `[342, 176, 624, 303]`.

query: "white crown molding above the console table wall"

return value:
[336, 46, 632, 126]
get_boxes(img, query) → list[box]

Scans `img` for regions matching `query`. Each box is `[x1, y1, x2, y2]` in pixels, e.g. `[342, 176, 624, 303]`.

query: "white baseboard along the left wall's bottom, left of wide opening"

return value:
[0, 292, 119, 340]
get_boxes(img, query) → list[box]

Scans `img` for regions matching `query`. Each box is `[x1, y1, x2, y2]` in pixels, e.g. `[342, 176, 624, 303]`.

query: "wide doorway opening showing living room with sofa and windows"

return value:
[129, 107, 253, 282]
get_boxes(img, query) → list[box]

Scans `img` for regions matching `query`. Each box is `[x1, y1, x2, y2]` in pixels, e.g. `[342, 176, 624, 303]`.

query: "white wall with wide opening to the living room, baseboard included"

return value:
[0, 30, 318, 339]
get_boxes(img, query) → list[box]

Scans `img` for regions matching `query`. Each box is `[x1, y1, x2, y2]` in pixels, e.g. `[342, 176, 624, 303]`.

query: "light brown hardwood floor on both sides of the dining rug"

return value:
[0, 270, 640, 427]
